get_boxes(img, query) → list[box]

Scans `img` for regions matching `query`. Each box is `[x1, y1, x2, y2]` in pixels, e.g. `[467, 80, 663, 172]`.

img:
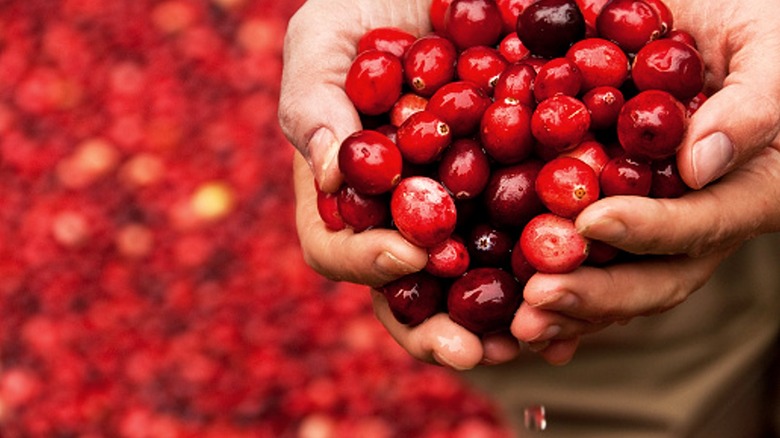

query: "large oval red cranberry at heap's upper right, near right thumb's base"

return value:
[631, 38, 704, 101]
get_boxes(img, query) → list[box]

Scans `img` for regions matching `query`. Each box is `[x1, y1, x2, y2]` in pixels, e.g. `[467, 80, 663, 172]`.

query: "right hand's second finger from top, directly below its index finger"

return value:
[524, 251, 729, 323]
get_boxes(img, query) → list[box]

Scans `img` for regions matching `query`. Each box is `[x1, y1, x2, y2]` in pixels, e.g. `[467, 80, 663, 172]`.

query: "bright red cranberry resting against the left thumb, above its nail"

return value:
[344, 50, 403, 116]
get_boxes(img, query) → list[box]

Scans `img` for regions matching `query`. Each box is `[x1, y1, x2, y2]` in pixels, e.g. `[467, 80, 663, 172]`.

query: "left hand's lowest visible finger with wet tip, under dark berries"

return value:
[371, 290, 483, 370]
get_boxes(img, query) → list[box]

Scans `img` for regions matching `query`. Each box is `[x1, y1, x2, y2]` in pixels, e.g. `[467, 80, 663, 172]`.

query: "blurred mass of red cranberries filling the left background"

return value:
[0, 0, 506, 438]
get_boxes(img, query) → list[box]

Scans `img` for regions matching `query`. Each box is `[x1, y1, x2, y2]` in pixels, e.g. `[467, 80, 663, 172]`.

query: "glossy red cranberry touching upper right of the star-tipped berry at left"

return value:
[427, 81, 492, 137]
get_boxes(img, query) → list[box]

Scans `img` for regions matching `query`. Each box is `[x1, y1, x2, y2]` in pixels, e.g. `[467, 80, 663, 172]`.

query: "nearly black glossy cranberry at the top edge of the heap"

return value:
[516, 0, 585, 58]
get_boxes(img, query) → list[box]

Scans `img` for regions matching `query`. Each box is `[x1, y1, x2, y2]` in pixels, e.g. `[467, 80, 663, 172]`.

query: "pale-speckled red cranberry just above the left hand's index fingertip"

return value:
[390, 176, 457, 248]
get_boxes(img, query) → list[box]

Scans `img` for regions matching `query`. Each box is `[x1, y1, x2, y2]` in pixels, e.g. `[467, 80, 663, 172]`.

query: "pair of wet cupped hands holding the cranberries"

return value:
[279, 0, 780, 369]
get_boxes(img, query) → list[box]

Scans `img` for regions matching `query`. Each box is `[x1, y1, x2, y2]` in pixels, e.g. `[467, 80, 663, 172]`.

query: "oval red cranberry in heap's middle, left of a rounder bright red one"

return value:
[480, 99, 534, 164]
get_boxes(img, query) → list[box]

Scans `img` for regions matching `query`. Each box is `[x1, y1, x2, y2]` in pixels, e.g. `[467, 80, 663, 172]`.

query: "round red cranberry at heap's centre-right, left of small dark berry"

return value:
[531, 95, 590, 152]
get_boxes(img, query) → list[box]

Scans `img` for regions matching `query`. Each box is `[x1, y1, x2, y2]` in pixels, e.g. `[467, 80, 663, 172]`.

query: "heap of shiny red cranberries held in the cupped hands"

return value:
[318, 0, 706, 334]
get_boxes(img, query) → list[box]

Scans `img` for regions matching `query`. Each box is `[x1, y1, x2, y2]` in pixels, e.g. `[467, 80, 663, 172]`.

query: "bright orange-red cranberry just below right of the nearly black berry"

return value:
[566, 38, 629, 91]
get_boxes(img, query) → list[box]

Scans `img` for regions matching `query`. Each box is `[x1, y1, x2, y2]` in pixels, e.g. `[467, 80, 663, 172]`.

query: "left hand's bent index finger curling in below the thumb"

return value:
[294, 154, 428, 286]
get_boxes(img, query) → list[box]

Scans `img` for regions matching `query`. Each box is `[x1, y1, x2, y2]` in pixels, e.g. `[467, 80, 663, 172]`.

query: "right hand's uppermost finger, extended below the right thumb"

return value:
[576, 148, 780, 256]
